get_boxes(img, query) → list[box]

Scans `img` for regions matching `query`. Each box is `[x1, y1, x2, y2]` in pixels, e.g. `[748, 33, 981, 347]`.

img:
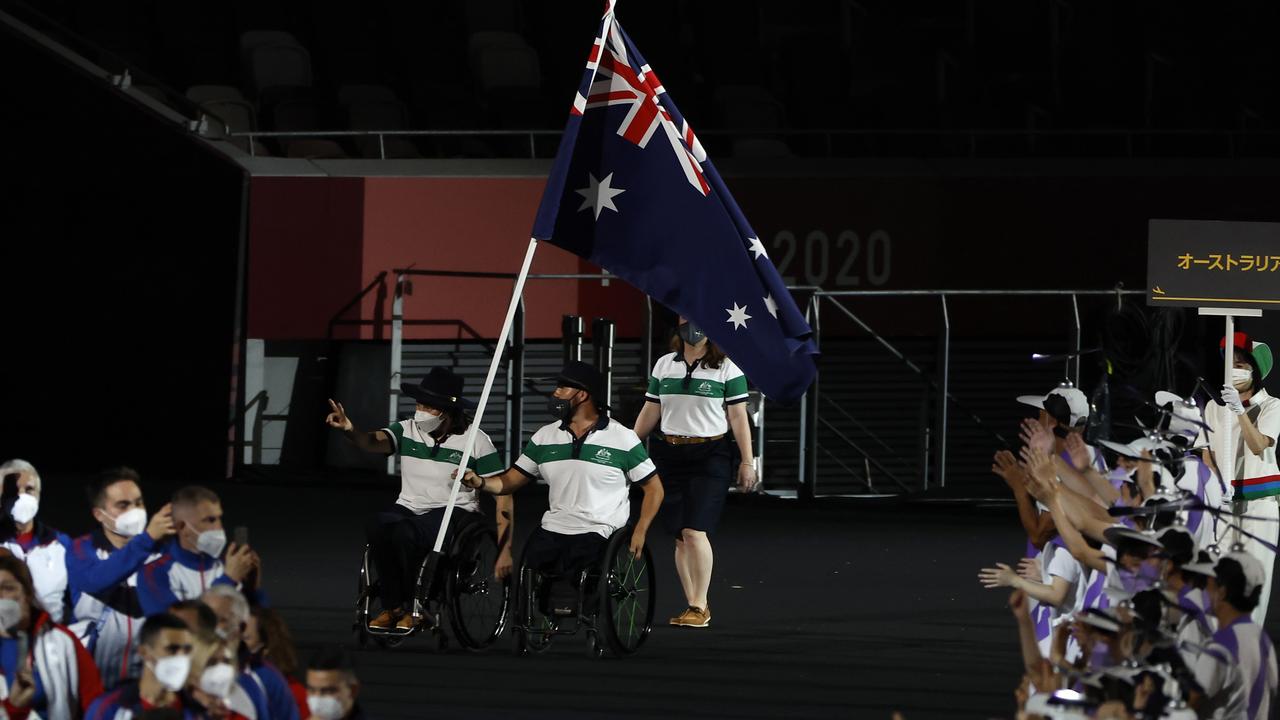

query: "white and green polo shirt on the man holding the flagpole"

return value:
[516, 415, 657, 537]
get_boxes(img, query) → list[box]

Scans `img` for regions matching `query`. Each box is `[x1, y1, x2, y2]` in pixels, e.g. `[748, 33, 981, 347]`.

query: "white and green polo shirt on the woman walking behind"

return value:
[645, 352, 746, 437]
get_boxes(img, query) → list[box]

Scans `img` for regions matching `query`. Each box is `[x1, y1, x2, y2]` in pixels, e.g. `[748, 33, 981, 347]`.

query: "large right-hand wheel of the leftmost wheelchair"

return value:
[444, 524, 511, 650]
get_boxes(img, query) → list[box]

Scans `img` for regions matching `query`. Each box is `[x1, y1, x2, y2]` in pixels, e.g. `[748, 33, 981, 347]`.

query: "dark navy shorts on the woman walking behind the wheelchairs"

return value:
[650, 437, 733, 538]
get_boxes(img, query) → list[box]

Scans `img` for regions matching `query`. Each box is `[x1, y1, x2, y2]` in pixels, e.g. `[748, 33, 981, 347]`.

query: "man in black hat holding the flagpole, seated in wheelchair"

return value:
[463, 361, 662, 614]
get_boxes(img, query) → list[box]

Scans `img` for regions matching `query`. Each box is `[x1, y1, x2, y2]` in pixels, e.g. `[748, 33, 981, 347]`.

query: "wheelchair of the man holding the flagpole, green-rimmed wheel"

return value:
[511, 527, 657, 657]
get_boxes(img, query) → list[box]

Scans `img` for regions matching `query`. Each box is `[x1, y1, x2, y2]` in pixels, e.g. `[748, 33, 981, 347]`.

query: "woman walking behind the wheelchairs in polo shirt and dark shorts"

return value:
[635, 318, 756, 628]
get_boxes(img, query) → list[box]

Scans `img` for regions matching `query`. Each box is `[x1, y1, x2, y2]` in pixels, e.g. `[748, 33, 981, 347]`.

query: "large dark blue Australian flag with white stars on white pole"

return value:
[532, 1, 818, 402]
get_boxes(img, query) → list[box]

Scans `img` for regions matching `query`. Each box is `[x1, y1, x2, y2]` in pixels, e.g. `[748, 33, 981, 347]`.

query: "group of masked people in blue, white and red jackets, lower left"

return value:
[0, 460, 362, 720]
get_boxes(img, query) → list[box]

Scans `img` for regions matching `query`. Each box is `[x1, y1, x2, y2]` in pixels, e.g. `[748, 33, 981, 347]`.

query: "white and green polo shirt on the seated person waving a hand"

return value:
[383, 419, 504, 515]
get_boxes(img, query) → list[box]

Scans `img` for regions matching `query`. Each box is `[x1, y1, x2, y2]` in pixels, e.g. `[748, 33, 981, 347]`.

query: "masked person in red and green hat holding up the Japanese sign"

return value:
[1197, 332, 1280, 624]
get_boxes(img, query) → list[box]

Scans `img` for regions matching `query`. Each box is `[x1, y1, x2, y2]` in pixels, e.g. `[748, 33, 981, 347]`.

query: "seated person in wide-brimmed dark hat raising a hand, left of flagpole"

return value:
[326, 368, 513, 632]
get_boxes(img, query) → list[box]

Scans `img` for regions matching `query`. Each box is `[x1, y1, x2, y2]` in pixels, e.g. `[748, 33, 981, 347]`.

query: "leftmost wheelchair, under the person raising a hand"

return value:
[353, 512, 511, 651]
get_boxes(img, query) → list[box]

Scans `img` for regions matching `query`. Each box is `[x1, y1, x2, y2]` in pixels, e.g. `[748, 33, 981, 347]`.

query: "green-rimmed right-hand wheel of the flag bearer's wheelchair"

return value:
[596, 528, 657, 656]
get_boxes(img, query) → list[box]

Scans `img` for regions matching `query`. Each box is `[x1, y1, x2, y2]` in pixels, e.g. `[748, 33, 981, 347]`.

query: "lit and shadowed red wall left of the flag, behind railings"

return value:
[248, 177, 644, 340]
